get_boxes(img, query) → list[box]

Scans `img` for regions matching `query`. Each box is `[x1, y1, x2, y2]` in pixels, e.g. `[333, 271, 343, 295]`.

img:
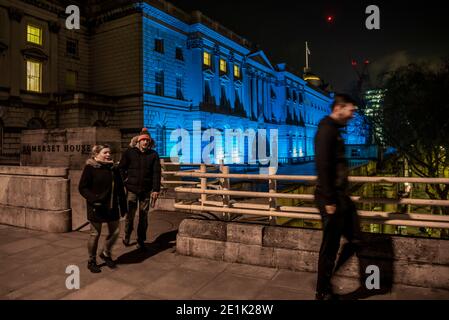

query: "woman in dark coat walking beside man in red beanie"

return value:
[79, 145, 128, 273]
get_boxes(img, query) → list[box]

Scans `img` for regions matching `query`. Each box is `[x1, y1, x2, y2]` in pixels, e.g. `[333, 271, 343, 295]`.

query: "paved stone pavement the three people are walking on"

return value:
[0, 211, 449, 300]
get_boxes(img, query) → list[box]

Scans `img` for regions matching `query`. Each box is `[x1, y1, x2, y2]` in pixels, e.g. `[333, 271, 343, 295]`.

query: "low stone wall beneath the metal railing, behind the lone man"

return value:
[176, 219, 449, 289]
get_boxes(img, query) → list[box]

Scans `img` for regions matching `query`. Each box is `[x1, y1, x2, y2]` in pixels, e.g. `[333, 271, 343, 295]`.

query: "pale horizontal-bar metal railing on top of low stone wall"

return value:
[162, 163, 449, 229]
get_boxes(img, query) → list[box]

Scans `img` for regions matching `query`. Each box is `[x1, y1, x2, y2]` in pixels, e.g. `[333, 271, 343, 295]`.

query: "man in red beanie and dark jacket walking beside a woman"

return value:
[119, 128, 161, 250]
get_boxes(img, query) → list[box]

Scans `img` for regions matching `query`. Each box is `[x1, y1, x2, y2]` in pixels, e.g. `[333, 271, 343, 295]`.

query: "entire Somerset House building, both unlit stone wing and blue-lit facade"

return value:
[0, 0, 365, 163]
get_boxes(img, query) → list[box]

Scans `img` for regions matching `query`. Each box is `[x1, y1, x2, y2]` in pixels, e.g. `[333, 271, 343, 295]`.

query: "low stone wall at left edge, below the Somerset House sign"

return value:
[0, 166, 72, 232]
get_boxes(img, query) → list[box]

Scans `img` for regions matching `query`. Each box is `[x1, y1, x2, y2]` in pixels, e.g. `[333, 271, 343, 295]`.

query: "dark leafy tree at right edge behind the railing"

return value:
[375, 59, 449, 211]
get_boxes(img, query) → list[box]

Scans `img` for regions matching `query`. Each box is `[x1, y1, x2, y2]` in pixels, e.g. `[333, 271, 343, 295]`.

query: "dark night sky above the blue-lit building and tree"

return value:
[170, 0, 449, 91]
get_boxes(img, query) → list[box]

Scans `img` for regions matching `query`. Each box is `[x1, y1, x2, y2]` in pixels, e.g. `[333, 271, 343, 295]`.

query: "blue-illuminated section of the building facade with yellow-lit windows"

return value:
[139, 3, 365, 163]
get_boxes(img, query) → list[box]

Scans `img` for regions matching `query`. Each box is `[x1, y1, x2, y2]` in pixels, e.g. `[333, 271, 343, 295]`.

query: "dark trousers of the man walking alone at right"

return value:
[315, 192, 360, 293]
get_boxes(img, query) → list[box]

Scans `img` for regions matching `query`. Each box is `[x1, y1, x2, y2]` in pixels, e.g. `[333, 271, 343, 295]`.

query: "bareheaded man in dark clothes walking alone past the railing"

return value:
[315, 94, 360, 300]
